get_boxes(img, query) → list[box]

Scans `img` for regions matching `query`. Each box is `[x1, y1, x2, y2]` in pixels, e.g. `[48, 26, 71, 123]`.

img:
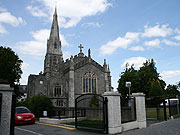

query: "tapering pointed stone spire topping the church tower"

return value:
[49, 7, 59, 40]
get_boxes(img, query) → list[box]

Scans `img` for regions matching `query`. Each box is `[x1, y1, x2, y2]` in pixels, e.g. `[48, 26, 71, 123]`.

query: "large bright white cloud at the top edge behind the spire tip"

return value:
[27, 0, 111, 28]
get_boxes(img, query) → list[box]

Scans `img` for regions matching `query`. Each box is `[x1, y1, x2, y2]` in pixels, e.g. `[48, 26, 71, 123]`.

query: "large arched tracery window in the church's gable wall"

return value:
[82, 71, 98, 94]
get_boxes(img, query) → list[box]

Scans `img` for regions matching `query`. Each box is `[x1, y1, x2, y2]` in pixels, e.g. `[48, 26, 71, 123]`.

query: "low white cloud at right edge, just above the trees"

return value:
[160, 70, 180, 79]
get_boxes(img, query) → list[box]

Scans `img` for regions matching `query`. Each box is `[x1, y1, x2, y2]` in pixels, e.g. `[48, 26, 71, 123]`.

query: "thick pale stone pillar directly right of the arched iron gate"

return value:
[103, 92, 122, 134]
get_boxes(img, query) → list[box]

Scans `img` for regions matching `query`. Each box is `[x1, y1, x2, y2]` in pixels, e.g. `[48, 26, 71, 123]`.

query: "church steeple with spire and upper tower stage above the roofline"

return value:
[44, 8, 63, 78]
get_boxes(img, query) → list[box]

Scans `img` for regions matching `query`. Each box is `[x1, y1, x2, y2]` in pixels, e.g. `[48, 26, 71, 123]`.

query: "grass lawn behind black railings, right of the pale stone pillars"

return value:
[146, 108, 169, 119]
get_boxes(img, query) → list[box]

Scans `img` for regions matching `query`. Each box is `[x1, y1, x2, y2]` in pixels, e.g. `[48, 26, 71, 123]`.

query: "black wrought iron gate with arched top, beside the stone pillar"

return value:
[75, 94, 108, 133]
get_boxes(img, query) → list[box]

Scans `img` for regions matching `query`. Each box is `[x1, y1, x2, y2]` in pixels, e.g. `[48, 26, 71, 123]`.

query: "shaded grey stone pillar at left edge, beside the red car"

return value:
[0, 84, 14, 135]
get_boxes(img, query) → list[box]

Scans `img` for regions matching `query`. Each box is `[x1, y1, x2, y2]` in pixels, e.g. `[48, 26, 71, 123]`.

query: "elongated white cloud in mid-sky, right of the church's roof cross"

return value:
[100, 37, 133, 56]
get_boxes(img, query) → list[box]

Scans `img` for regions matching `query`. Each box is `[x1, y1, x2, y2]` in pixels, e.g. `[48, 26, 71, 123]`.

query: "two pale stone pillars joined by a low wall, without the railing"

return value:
[103, 92, 146, 134]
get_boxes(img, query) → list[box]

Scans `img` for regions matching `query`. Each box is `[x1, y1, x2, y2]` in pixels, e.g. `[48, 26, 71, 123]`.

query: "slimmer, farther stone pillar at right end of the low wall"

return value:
[132, 93, 146, 128]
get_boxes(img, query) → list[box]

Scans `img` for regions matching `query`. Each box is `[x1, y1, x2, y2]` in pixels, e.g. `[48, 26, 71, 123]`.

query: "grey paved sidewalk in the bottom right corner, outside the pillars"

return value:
[119, 118, 180, 135]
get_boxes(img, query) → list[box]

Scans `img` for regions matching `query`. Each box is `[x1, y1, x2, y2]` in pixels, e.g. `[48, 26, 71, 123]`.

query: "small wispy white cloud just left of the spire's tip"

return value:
[27, 6, 48, 17]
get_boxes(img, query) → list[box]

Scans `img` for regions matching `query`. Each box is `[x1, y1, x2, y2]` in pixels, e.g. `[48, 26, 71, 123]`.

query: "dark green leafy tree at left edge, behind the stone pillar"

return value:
[0, 46, 22, 95]
